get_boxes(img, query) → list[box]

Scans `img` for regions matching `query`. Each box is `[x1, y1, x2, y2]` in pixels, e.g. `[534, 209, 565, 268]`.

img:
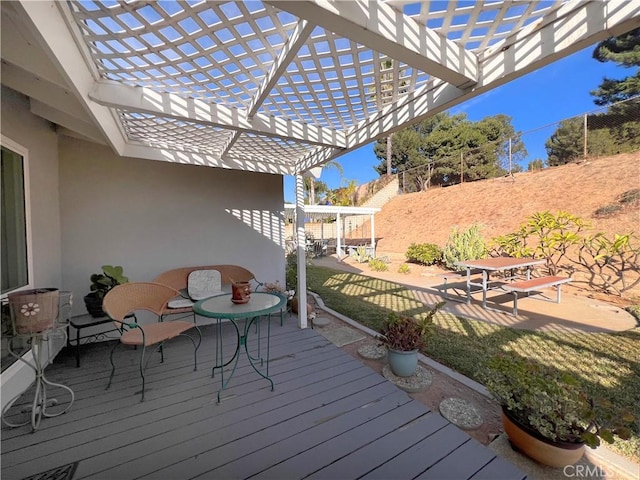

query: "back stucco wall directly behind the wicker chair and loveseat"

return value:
[59, 137, 284, 315]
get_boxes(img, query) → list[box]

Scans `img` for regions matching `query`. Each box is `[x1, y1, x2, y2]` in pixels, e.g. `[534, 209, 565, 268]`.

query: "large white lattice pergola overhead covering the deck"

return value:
[5, 0, 640, 326]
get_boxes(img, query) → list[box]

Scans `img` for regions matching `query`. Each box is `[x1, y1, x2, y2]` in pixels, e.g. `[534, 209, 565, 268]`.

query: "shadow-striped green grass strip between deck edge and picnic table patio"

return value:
[307, 266, 640, 462]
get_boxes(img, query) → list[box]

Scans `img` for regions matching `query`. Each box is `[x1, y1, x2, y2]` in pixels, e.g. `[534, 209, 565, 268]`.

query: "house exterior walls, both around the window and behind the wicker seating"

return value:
[0, 87, 285, 408]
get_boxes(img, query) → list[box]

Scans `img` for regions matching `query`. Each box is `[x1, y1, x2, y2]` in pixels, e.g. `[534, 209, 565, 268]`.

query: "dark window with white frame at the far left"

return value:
[0, 137, 32, 296]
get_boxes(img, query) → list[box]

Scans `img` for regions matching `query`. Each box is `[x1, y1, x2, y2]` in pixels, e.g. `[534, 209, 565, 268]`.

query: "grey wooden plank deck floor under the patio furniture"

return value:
[2, 319, 525, 480]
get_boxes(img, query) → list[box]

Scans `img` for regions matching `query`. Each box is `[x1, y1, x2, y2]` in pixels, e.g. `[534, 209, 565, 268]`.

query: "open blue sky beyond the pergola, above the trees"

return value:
[284, 46, 635, 202]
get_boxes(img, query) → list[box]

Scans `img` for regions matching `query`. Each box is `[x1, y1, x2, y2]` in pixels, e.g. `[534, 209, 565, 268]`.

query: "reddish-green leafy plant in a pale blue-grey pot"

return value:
[378, 302, 445, 377]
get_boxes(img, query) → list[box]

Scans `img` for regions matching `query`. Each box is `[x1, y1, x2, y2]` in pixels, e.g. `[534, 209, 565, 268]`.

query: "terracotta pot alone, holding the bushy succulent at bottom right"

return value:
[502, 408, 584, 467]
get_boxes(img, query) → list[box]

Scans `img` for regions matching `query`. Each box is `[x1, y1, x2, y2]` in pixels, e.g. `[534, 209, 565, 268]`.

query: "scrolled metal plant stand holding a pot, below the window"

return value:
[2, 326, 75, 431]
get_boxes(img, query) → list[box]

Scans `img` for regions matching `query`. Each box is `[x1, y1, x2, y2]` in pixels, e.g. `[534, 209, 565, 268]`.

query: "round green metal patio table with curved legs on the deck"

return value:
[193, 292, 287, 403]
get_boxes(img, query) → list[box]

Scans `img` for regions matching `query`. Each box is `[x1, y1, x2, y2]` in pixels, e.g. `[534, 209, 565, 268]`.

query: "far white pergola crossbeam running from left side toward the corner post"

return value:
[89, 80, 346, 147]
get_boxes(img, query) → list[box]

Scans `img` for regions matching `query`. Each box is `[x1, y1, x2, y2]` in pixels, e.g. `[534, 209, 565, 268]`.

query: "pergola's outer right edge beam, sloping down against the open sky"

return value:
[346, 0, 640, 151]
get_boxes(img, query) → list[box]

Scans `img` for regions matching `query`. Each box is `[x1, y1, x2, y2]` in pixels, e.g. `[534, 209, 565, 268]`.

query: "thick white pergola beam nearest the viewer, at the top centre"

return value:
[266, 0, 478, 88]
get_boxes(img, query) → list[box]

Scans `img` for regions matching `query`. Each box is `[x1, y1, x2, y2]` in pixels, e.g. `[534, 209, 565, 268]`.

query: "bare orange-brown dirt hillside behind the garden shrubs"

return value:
[375, 152, 640, 259]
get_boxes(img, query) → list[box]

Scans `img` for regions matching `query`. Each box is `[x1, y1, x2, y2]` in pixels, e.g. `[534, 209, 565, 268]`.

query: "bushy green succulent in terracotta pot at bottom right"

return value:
[481, 354, 634, 467]
